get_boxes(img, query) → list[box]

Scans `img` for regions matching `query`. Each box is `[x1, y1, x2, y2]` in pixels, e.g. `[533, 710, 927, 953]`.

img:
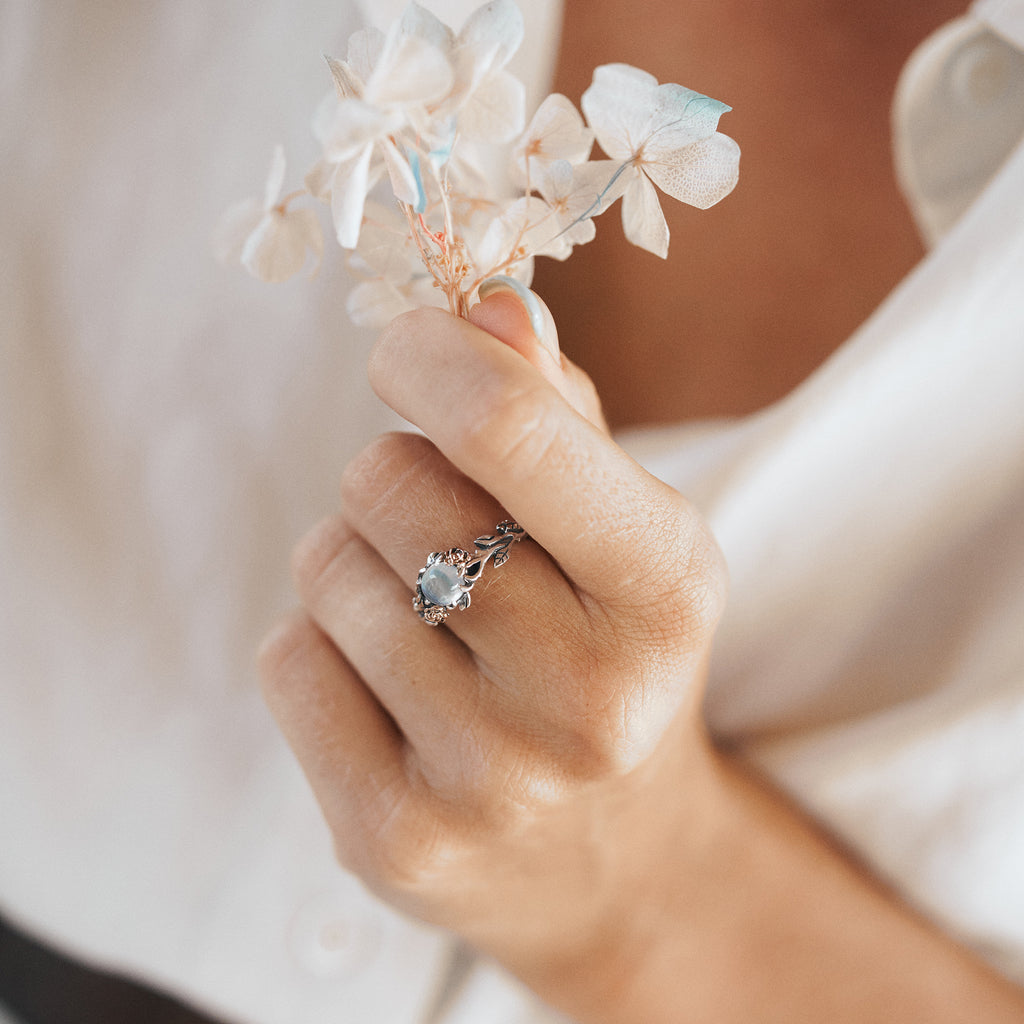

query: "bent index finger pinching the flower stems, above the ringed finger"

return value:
[370, 309, 717, 603]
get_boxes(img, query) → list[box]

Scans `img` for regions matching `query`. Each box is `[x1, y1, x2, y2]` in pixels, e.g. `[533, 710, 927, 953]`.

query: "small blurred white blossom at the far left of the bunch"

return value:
[213, 145, 324, 282]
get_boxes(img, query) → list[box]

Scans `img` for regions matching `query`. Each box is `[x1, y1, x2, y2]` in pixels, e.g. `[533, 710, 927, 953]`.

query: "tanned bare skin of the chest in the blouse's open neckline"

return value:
[537, 0, 964, 426]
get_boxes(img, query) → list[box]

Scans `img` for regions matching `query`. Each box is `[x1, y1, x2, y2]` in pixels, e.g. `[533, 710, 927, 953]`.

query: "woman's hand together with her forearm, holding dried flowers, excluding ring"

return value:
[261, 293, 1024, 1024]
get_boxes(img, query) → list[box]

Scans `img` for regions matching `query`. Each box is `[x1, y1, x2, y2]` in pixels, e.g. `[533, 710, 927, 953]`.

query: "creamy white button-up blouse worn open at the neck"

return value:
[0, 0, 1024, 1024]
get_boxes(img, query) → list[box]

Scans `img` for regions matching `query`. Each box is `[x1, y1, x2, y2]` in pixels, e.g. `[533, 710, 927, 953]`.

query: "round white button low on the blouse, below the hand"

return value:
[288, 891, 381, 980]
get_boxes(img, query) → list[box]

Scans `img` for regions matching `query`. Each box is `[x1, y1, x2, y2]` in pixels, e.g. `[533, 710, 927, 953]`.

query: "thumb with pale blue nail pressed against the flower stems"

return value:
[469, 275, 609, 433]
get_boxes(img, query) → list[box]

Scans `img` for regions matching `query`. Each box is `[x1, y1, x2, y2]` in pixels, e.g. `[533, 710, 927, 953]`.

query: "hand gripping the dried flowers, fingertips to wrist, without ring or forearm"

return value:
[261, 292, 725, 1001]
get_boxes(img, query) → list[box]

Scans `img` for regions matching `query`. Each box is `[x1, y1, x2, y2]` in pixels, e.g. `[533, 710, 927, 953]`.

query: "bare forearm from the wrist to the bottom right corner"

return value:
[536, 755, 1024, 1024]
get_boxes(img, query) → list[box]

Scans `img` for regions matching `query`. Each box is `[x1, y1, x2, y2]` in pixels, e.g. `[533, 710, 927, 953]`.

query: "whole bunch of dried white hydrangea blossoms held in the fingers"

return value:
[216, 0, 738, 325]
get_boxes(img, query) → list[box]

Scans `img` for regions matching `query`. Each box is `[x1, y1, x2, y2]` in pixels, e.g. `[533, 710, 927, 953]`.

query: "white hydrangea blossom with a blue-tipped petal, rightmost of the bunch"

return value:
[583, 65, 739, 258]
